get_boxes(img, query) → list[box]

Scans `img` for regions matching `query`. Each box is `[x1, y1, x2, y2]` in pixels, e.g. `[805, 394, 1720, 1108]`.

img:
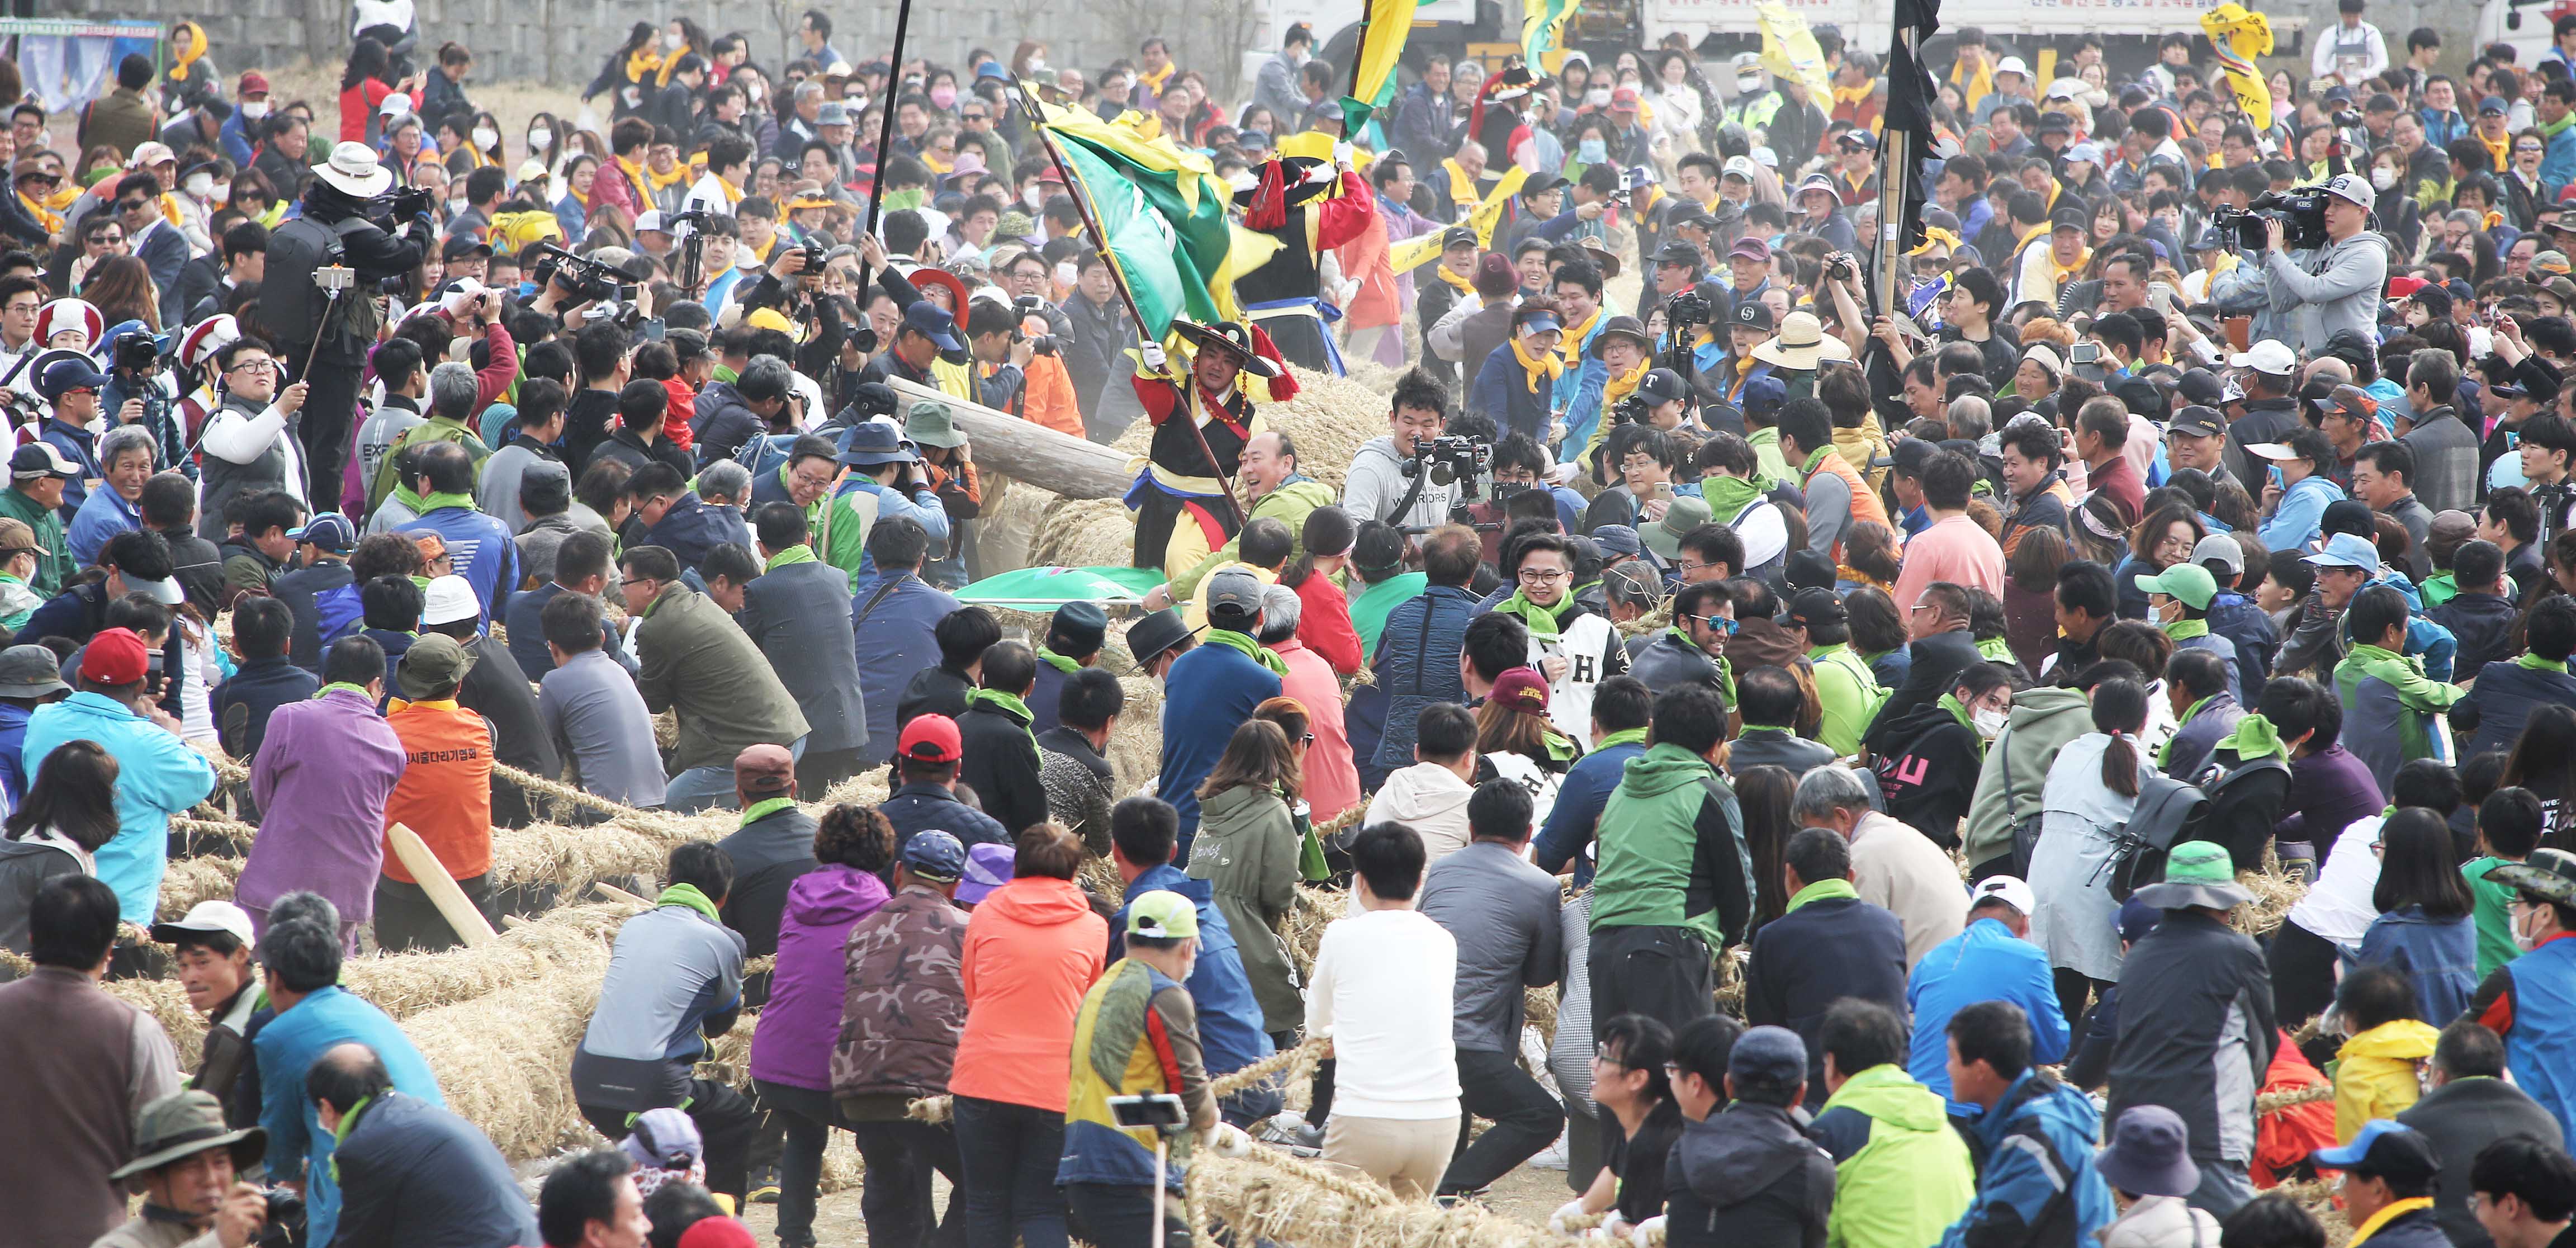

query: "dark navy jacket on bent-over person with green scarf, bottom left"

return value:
[332, 1091, 538, 1248]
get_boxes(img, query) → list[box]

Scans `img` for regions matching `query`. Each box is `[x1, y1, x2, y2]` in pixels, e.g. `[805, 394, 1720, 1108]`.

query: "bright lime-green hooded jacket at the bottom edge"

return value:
[1819, 1057, 1978, 1248]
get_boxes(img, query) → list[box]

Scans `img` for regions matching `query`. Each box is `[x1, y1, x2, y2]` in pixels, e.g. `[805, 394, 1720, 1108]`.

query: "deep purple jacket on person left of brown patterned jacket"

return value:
[752, 864, 886, 1093]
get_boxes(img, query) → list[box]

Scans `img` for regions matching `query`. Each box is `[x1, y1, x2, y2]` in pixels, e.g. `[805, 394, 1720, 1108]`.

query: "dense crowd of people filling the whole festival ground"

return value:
[0, 0, 2576, 1248]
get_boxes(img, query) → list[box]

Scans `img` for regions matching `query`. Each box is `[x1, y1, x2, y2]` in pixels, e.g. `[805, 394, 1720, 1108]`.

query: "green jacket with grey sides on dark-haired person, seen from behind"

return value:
[1592, 745, 1754, 952]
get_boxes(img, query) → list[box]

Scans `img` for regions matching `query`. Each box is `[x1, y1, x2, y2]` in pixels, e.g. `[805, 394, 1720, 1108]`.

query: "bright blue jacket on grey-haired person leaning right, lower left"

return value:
[253, 985, 448, 1243]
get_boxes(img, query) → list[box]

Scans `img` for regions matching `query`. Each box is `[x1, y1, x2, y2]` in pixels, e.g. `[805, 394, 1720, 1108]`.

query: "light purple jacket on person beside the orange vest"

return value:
[234, 688, 402, 923]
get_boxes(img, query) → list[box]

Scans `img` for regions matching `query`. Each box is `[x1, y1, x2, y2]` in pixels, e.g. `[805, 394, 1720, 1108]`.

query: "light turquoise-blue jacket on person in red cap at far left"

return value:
[18, 694, 216, 923]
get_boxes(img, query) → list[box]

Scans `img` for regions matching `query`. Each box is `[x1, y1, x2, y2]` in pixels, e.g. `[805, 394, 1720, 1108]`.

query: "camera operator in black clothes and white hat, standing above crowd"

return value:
[260, 142, 438, 500]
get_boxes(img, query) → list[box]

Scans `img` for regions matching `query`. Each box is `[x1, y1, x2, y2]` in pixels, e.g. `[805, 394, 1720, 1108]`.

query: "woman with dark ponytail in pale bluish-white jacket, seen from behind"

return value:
[2030, 675, 2156, 1019]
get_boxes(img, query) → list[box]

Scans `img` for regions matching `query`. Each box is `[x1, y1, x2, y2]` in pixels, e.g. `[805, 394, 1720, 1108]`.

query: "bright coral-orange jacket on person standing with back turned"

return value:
[948, 877, 1110, 1114]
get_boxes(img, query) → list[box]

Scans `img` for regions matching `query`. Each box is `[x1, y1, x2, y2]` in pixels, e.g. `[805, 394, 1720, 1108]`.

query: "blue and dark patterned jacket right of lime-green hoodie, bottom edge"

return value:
[1940, 1067, 2118, 1248]
